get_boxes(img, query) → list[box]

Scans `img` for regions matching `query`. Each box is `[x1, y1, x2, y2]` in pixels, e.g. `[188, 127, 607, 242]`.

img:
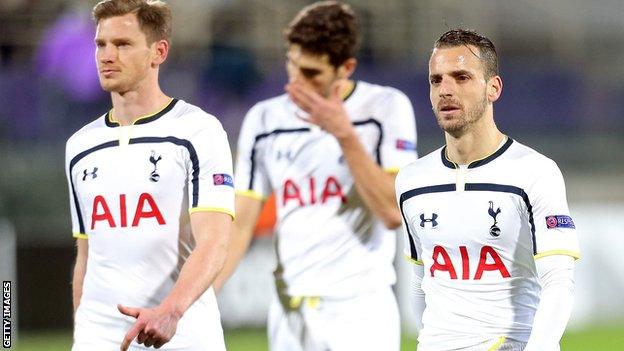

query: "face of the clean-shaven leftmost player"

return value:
[95, 13, 156, 94]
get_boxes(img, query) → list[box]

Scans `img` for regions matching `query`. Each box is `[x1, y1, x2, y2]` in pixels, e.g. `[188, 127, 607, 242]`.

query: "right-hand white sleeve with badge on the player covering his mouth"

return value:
[378, 89, 418, 173]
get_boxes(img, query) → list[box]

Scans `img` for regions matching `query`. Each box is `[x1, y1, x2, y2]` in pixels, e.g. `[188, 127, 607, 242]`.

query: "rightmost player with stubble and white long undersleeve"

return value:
[396, 29, 580, 351]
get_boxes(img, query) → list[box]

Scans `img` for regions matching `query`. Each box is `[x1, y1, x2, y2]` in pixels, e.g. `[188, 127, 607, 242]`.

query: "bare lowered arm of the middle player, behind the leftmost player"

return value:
[213, 194, 263, 291]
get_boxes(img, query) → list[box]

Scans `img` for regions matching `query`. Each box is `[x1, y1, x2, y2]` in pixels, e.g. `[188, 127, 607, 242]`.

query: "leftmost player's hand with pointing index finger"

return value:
[117, 305, 180, 351]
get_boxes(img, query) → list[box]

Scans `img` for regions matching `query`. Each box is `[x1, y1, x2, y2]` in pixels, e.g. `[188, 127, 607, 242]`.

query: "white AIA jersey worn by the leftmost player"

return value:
[66, 99, 234, 347]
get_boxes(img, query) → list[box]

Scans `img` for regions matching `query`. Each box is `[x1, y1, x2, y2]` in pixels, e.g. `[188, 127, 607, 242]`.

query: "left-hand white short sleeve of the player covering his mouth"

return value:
[235, 105, 271, 199]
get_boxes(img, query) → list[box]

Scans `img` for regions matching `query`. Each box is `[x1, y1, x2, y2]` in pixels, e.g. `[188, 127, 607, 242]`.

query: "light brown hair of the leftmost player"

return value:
[92, 0, 171, 44]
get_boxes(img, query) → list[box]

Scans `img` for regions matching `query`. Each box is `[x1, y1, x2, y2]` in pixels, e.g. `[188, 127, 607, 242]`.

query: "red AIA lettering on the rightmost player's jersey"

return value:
[429, 245, 511, 280]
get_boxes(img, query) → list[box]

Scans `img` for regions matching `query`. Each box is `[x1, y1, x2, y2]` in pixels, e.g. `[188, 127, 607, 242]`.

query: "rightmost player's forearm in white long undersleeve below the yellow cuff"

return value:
[524, 255, 574, 351]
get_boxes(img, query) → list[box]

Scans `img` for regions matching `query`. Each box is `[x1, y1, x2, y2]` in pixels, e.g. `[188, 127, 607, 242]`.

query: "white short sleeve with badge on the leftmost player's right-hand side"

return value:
[187, 120, 234, 217]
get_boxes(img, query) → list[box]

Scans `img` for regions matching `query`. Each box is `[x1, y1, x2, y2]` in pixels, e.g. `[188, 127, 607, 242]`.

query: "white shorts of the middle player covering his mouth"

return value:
[268, 287, 401, 351]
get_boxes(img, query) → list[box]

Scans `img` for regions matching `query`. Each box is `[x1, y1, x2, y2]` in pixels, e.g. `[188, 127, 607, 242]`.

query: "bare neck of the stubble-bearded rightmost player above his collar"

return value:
[445, 117, 505, 165]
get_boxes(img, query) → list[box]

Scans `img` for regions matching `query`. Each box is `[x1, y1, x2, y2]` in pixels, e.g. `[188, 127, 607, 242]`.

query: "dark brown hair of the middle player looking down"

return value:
[284, 1, 357, 67]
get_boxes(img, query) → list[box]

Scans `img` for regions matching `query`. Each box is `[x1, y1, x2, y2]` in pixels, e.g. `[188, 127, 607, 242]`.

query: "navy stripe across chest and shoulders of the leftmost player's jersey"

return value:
[68, 137, 199, 234]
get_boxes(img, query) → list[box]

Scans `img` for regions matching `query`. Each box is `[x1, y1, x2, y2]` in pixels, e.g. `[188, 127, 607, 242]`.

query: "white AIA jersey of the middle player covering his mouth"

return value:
[236, 81, 417, 297]
